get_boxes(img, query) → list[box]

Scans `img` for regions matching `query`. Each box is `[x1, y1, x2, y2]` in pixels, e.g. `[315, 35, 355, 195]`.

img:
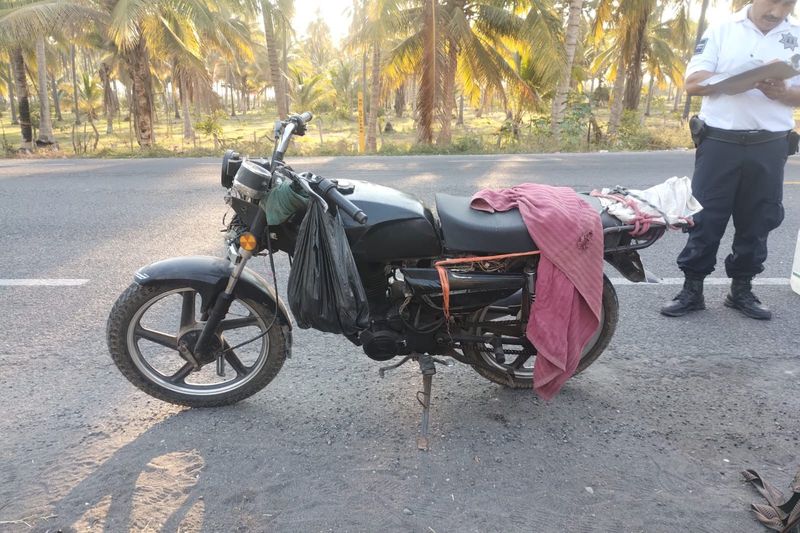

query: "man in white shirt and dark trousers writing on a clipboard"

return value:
[661, 0, 800, 320]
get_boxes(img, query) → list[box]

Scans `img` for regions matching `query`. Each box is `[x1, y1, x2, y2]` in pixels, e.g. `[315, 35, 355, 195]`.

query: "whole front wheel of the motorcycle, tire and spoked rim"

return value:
[106, 283, 289, 407]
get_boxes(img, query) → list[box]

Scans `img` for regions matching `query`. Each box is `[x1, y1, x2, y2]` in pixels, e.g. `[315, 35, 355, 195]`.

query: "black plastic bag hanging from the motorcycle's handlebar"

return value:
[288, 200, 369, 335]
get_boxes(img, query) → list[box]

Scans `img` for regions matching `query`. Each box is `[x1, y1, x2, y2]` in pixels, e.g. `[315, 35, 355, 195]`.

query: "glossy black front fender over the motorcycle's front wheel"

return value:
[134, 256, 292, 329]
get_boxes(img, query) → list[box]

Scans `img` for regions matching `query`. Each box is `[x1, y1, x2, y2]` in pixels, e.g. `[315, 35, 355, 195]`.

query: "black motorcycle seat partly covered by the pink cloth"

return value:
[436, 193, 623, 254]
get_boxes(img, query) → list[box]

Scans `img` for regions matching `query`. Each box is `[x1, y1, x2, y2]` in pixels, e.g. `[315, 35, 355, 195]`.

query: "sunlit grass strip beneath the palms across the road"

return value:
[0, 100, 691, 157]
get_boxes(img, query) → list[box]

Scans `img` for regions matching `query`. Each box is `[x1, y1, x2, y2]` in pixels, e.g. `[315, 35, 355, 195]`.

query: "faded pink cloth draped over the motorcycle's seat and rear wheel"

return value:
[470, 183, 603, 400]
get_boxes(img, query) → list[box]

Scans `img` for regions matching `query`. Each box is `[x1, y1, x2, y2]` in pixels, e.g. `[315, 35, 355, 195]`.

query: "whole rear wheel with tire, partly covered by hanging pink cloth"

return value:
[464, 276, 619, 389]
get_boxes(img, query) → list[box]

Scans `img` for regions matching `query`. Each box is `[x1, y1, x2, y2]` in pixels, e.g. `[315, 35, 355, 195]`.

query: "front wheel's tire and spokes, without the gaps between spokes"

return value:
[106, 283, 289, 407]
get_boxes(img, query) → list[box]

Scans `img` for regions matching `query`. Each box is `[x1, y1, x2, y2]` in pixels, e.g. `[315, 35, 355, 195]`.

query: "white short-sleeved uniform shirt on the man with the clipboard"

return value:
[686, 6, 800, 131]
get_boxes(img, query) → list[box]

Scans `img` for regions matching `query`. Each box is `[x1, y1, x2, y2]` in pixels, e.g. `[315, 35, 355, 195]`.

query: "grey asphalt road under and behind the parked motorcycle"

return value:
[0, 152, 800, 533]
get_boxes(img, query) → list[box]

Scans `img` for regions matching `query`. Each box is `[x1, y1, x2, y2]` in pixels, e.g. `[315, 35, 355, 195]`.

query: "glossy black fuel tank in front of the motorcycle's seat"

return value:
[340, 180, 442, 263]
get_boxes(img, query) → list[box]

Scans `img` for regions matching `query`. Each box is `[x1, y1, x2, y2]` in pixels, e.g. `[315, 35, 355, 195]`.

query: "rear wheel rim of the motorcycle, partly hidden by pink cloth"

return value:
[471, 307, 605, 380]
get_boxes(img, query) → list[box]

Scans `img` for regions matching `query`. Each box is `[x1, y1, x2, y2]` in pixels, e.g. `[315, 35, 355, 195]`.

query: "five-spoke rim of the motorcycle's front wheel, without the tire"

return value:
[127, 287, 269, 396]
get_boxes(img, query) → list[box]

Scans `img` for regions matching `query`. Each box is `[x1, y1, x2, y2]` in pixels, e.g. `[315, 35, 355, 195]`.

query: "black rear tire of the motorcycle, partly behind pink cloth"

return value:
[464, 275, 619, 389]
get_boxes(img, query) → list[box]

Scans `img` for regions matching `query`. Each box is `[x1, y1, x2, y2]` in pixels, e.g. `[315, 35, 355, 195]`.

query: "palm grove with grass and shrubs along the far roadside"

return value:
[0, 0, 741, 157]
